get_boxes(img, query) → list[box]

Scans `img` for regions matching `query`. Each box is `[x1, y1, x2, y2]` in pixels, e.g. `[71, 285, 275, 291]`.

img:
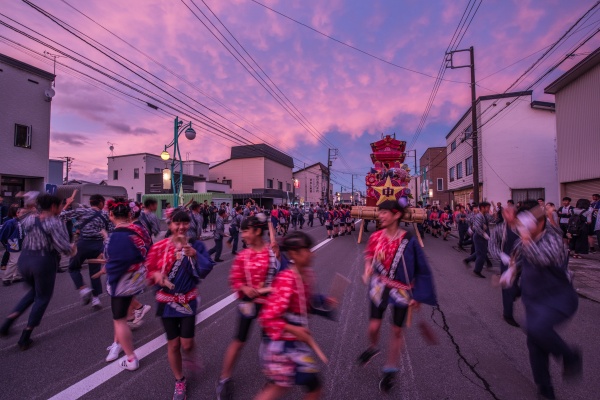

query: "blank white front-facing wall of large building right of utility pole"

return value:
[480, 96, 560, 204]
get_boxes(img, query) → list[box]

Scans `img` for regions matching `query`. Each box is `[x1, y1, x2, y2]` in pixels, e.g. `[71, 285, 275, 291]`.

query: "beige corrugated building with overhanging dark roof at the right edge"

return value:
[544, 48, 600, 201]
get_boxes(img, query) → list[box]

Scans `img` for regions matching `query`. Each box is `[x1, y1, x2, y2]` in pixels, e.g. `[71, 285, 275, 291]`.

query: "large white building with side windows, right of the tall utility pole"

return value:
[446, 91, 560, 204]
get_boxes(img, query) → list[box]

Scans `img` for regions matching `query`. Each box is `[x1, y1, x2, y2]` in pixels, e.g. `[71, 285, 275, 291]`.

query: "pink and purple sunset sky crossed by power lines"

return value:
[0, 0, 600, 194]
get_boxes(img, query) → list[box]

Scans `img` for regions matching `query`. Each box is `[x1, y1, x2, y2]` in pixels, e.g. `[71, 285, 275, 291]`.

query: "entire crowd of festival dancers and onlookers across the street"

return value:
[0, 193, 600, 400]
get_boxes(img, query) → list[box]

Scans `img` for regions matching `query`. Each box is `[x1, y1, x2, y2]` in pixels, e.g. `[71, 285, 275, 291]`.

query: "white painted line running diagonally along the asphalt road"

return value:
[49, 239, 332, 400]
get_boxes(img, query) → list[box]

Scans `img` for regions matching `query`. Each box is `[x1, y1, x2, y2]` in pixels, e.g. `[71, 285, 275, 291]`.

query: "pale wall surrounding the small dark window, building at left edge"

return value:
[0, 57, 53, 190]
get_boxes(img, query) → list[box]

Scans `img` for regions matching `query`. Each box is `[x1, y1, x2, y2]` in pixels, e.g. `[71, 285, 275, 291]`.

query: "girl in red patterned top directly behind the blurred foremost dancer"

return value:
[217, 214, 281, 400]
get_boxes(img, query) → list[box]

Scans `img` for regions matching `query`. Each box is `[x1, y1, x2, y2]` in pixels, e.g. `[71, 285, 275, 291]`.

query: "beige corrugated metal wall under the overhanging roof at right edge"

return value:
[556, 65, 600, 183]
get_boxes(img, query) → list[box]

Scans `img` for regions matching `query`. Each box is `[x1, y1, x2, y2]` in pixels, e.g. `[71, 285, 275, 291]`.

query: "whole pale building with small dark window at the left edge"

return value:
[0, 54, 54, 204]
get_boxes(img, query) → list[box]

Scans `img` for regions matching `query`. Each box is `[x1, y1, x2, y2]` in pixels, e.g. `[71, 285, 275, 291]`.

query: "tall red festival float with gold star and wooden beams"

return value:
[352, 135, 426, 246]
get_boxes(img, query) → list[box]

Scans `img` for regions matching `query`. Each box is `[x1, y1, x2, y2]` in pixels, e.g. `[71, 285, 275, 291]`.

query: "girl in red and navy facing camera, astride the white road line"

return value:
[146, 210, 214, 400]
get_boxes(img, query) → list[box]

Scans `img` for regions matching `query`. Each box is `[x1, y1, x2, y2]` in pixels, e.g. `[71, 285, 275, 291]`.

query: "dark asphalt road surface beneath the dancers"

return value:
[0, 222, 600, 399]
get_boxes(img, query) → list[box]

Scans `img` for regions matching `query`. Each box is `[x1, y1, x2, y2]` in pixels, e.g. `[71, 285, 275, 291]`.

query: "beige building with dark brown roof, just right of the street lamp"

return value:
[209, 144, 294, 206]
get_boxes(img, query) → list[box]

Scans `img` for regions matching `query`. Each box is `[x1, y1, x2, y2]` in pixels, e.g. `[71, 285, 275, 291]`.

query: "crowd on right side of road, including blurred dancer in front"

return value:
[418, 194, 600, 399]
